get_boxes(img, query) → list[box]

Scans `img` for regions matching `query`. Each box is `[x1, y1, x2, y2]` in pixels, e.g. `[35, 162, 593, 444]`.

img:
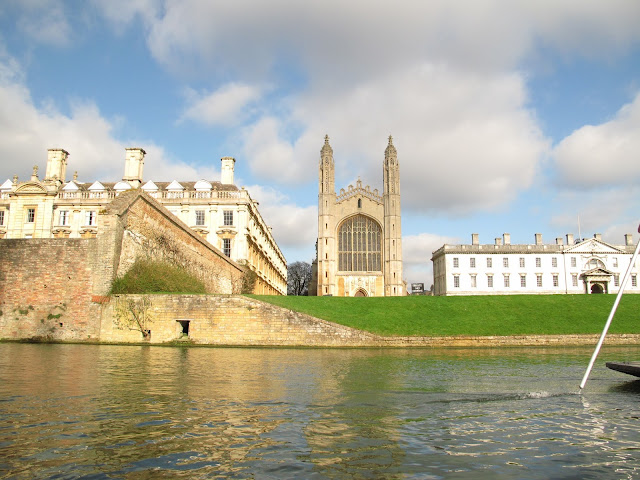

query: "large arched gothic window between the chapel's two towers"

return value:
[338, 215, 382, 272]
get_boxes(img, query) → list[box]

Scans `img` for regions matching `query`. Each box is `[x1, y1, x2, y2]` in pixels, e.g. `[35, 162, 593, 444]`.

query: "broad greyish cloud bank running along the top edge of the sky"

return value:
[140, 0, 640, 81]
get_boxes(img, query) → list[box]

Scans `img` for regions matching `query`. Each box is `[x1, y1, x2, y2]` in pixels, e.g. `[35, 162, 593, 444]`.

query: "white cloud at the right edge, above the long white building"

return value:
[553, 93, 640, 189]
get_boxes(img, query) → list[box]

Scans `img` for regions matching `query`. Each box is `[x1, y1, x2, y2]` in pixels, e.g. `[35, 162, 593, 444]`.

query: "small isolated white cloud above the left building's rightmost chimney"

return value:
[180, 83, 261, 127]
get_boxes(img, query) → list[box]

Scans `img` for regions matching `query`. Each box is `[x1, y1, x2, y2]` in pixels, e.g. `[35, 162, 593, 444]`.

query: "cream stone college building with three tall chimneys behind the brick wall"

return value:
[0, 148, 287, 295]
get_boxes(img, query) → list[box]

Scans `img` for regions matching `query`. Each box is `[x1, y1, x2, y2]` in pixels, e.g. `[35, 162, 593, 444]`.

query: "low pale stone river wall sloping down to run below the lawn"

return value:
[100, 295, 640, 347]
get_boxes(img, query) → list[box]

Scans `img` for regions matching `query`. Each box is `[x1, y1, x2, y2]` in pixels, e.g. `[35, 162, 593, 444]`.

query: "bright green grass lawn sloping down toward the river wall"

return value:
[255, 295, 640, 336]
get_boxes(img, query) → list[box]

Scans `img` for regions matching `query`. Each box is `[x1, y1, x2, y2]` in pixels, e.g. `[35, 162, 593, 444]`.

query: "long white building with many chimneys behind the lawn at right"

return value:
[431, 233, 640, 295]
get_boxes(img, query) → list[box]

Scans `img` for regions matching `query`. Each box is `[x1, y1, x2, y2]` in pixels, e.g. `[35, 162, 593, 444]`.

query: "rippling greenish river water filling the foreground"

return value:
[0, 343, 640, 479]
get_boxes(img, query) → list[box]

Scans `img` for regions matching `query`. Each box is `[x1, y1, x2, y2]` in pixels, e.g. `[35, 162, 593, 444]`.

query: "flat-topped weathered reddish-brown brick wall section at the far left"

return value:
[0, 239, 100, 340]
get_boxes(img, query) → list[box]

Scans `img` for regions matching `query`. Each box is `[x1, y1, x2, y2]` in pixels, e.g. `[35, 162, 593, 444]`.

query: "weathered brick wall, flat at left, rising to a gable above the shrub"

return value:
[0, 190, 244, 341]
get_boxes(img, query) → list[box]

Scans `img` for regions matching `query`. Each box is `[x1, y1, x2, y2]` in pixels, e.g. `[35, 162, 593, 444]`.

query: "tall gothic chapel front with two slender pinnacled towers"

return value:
[309, 136, 406, 297]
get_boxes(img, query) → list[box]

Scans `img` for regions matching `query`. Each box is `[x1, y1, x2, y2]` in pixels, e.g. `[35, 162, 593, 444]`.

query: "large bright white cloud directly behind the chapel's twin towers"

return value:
[245, 65, 547, 213]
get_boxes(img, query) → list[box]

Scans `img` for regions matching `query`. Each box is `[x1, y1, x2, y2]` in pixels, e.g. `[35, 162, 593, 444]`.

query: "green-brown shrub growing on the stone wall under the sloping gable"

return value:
[110, 260, 206, 294]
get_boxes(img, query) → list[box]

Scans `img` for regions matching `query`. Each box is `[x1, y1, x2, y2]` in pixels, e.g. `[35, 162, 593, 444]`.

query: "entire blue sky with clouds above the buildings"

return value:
[0, 0, 640, 288]
